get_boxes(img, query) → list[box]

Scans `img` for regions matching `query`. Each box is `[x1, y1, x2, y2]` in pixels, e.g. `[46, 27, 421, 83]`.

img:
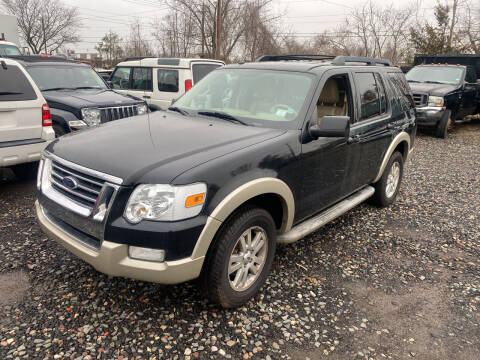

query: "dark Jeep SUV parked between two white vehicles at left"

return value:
[10, 55, 148, 137]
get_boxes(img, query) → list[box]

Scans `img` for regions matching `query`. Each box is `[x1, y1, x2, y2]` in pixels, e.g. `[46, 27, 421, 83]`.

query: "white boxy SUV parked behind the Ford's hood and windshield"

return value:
[110, 57, 225, 110]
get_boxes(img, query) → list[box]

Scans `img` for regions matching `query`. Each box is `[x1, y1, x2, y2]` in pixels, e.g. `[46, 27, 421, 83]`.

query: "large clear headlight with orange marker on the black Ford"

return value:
[123, 183, 207, 224]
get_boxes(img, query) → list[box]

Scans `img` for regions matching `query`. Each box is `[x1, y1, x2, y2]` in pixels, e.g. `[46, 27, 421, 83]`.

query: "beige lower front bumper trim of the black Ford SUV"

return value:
[35, 201, 204, 284]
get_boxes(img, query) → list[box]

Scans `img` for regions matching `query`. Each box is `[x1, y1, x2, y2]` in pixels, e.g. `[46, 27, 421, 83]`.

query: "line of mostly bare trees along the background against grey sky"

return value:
[0, 0, 480, 66]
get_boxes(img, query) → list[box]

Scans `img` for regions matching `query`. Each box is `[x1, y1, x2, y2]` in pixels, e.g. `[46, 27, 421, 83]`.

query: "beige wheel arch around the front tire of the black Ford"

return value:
[192, 177, 295, 258]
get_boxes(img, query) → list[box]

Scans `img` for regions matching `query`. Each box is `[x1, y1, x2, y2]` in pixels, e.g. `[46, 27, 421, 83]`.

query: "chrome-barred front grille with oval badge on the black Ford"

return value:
[50, 160, 105, 210]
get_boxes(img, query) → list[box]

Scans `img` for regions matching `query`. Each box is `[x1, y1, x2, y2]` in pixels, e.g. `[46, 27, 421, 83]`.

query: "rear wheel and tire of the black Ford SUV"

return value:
[370, 151, 403, 207]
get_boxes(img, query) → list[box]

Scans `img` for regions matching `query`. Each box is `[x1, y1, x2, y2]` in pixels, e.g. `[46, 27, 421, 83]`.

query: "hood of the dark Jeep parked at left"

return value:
[42, 89, 143, 110]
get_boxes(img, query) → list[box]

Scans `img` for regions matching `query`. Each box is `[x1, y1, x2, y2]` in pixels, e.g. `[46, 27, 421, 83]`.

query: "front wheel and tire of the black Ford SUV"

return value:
[199, 206, 277, 308]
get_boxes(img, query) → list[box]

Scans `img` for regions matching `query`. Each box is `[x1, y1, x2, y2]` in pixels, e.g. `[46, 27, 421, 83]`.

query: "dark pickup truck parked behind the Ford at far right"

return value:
[406, 55, 480, 138]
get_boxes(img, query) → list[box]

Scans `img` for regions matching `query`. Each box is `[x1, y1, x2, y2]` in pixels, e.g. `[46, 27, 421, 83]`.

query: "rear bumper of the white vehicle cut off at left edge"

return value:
[0, 129, 55, 167]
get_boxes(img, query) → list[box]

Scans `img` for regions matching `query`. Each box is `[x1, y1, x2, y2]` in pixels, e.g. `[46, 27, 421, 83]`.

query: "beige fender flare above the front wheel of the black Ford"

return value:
[192, 177, 295, 259]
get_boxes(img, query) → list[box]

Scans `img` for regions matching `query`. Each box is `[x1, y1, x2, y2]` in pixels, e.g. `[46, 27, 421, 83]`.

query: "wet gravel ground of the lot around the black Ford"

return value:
[0, 123, 480, 359]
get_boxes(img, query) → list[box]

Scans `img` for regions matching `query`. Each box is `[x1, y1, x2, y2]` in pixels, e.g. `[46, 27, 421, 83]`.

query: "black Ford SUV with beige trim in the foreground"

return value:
[36, 56, 416, 307]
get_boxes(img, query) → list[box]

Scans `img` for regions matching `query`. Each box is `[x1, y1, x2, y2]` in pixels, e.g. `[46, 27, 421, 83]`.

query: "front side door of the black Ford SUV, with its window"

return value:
[297, 71, 356, 220]
